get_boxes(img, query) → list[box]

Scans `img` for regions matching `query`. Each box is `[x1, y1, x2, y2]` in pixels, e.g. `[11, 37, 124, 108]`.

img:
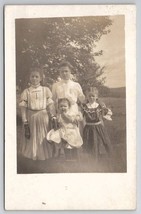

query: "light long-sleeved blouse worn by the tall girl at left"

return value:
[19, 86, 53, 110]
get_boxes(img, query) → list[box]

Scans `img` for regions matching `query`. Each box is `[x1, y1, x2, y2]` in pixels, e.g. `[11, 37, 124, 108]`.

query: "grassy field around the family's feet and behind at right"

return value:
[17, 97, 127, 173]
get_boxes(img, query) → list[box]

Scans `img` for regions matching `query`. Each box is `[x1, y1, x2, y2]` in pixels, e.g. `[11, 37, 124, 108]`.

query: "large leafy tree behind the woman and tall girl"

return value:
[16, 16, 112, 88]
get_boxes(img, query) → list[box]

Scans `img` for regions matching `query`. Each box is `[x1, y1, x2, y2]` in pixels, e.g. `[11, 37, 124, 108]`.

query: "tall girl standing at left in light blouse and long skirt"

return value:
[19, 68, 55, 160]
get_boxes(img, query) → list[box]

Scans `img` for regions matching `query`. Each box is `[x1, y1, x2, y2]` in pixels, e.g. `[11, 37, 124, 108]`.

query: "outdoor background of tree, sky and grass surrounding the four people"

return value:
[15, 15, 126, 173]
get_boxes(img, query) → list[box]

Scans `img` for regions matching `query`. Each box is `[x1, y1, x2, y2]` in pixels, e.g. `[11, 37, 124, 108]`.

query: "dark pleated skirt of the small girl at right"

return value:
[83, 124, 111, 158]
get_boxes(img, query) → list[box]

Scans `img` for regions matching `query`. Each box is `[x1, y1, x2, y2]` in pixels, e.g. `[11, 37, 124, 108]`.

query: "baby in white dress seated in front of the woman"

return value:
[47, 98, 83, 157]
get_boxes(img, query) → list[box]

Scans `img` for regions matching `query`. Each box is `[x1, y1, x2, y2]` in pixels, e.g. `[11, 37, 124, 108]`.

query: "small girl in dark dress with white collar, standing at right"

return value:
[82, 87, 112, 160]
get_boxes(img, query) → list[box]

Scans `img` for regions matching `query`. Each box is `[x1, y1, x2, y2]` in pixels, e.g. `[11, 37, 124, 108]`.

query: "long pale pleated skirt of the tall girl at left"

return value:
[21, 110, 52, 160]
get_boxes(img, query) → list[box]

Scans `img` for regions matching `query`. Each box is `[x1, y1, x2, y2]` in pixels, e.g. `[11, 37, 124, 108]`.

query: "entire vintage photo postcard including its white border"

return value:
[5, 5, 136, 210]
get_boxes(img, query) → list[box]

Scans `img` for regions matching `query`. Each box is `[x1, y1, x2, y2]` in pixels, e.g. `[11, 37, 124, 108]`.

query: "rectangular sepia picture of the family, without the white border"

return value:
[15, 15, 127, 173]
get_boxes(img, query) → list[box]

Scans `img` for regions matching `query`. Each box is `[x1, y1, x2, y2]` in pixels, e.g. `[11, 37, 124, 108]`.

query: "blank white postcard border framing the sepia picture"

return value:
[5, 5, 136, 210]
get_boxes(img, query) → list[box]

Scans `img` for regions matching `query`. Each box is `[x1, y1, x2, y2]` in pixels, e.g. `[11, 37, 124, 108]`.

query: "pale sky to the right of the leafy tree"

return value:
[95, 16, 125, 88]
